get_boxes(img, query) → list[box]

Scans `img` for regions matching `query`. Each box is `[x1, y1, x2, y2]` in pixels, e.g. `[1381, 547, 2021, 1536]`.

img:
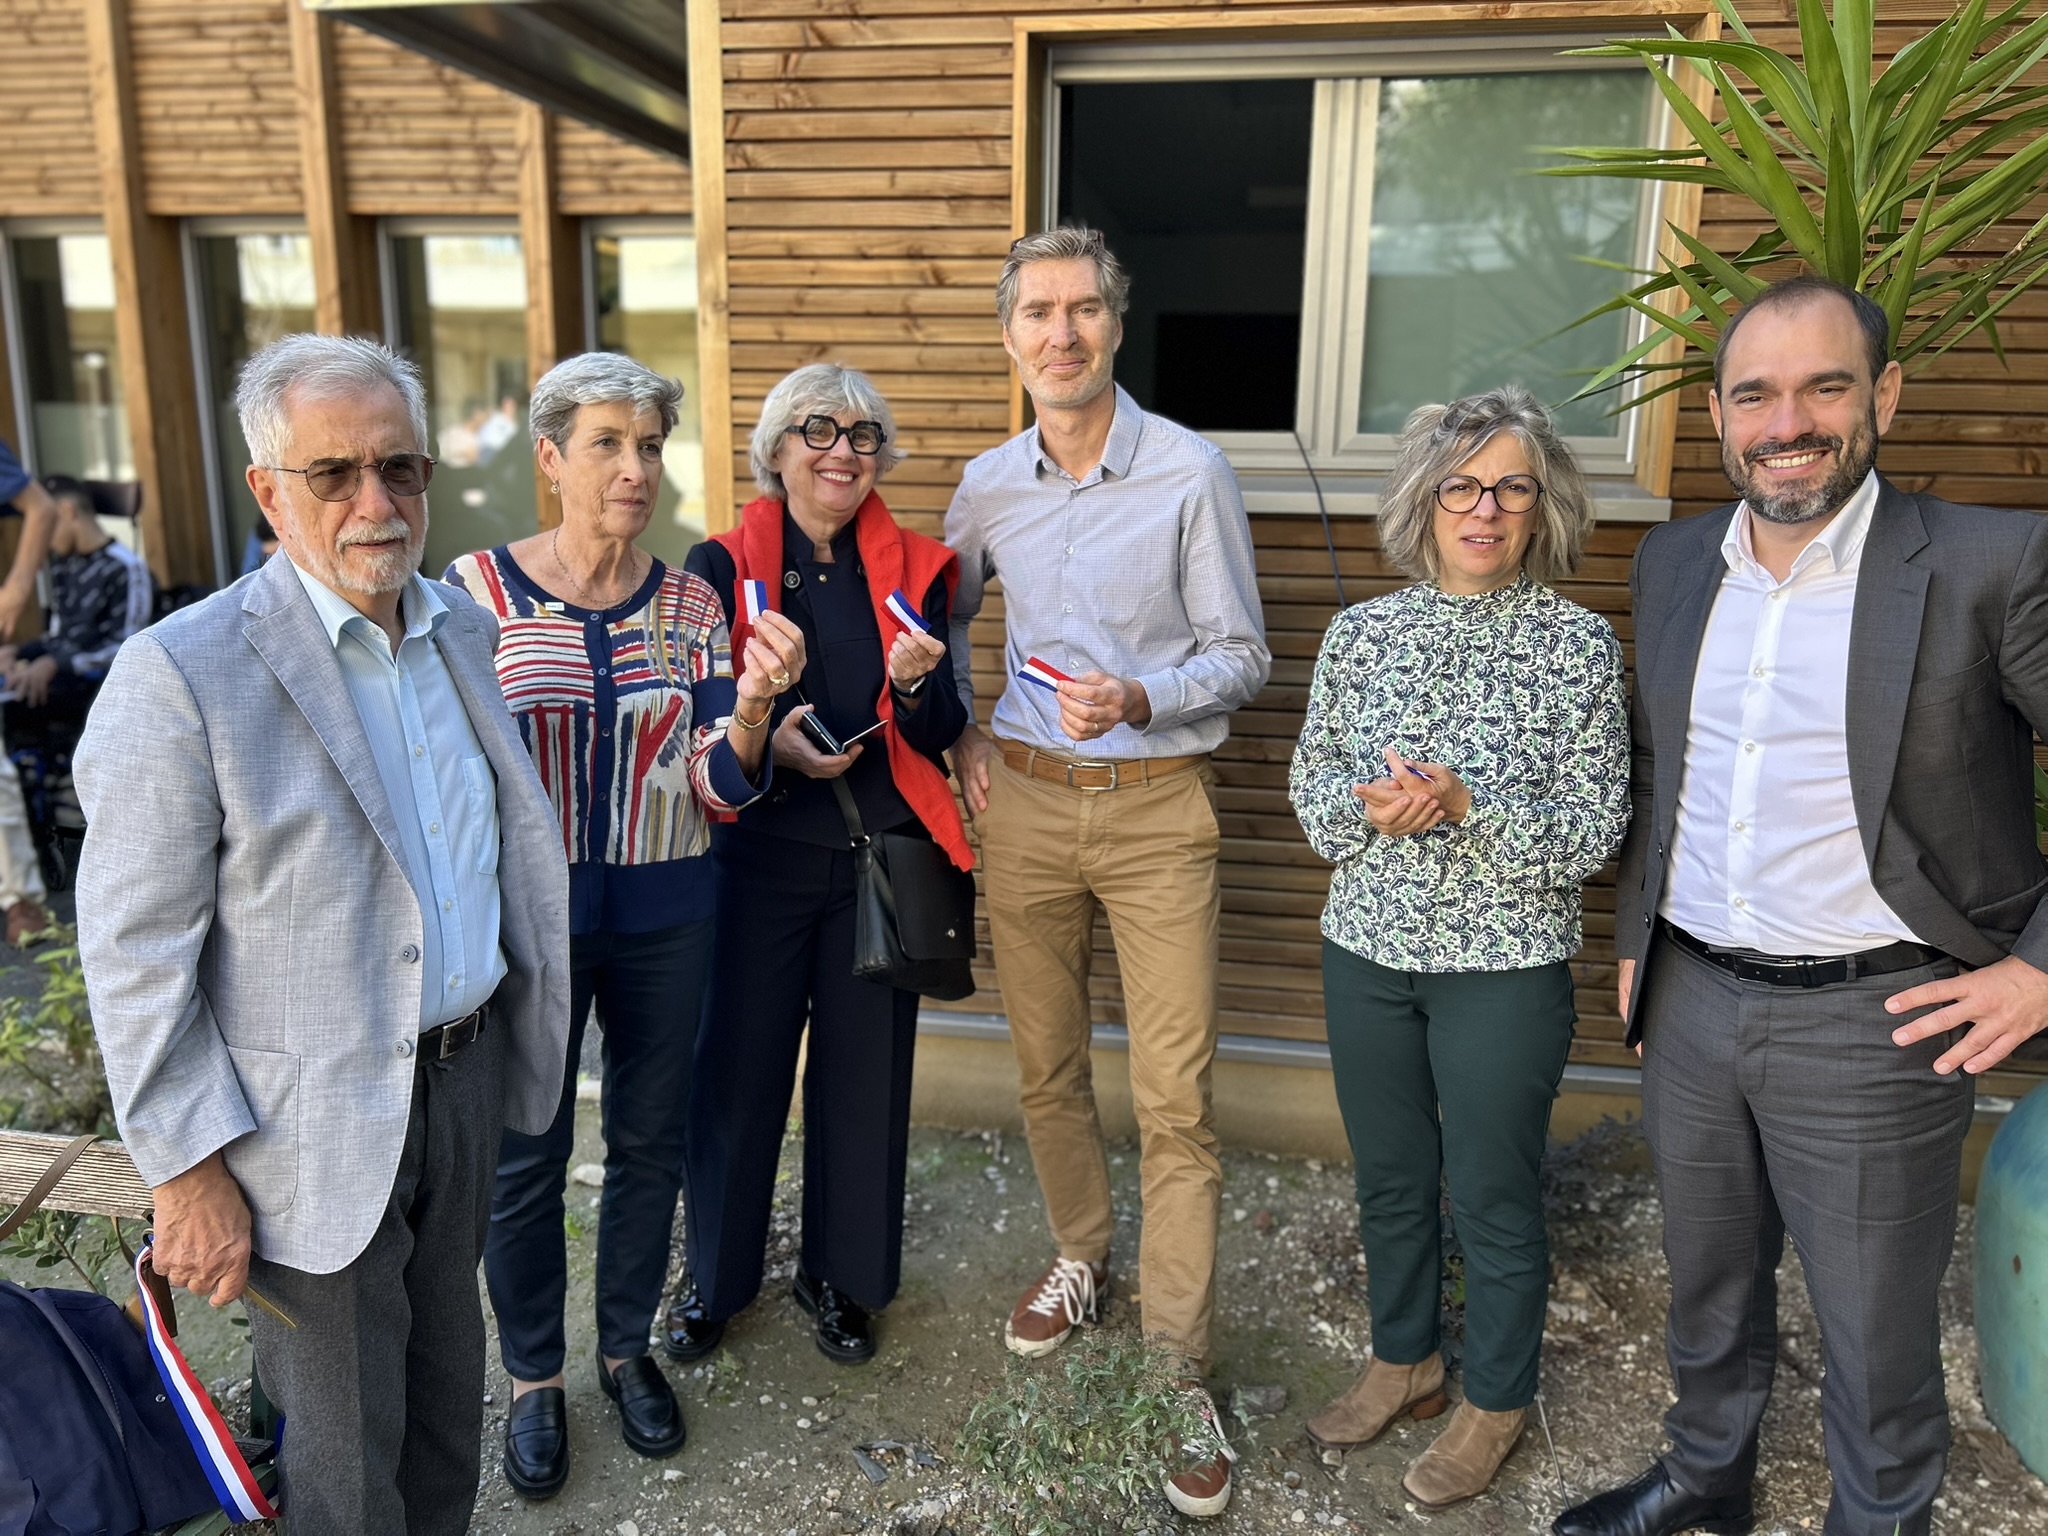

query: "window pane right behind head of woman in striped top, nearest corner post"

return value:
[590, 233, 705, 565]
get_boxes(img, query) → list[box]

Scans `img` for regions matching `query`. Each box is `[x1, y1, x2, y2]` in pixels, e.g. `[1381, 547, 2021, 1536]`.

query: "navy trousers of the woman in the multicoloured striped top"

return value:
[483, 920, 713, 1380]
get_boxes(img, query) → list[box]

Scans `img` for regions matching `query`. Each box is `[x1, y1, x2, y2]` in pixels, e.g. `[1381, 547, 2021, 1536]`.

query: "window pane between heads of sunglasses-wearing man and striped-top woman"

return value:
[391, 233, 539, 575]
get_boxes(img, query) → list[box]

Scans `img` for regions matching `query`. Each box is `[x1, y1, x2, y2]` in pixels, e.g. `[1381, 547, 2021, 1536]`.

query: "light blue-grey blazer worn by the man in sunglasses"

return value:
[74, 557, 569, 1274]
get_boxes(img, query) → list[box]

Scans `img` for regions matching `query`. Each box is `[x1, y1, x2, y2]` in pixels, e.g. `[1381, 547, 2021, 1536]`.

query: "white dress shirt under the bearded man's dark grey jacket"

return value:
[1659, 471, 1917, 954]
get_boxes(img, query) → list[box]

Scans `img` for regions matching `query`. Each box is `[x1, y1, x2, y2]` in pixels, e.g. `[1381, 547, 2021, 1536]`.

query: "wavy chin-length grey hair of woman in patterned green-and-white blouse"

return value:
[1380, 385, 1593, 586]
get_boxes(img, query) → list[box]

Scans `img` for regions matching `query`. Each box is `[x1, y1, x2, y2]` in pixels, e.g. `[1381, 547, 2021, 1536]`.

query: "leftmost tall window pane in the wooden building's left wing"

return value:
[12, 233, 135, 479]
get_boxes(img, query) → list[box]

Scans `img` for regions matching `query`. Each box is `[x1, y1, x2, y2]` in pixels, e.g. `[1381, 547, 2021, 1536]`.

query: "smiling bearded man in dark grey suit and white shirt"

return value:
[1554, 276, 2048, 1536]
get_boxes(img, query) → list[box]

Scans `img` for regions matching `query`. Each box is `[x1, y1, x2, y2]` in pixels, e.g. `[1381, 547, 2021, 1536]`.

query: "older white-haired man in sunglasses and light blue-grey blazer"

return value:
[76, 336, 569, 1536]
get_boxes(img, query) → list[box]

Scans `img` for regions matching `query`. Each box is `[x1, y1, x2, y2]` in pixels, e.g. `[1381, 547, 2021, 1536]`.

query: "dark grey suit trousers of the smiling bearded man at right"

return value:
[1640, 936, 1974, 1536]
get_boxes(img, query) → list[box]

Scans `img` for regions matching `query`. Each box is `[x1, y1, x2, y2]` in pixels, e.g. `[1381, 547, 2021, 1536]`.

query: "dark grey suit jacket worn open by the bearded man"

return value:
[1614, 477, 2048, 1044]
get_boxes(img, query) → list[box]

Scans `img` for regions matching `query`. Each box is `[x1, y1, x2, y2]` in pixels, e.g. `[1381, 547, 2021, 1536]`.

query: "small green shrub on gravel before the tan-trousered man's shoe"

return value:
[954, 1329, 1221, 1536]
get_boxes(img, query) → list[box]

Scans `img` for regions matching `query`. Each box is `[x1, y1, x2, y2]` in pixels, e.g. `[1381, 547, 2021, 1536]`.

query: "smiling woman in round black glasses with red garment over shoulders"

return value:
[666, 362, 973, 1364]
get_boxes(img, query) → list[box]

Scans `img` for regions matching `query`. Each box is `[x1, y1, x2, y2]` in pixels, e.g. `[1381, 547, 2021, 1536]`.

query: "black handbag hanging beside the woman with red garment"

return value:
[831, 778, 975, 1004]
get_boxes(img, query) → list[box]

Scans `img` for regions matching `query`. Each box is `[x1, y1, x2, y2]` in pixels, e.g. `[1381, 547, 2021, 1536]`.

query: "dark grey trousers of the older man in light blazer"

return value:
[250, 1026, 504, 1536]
